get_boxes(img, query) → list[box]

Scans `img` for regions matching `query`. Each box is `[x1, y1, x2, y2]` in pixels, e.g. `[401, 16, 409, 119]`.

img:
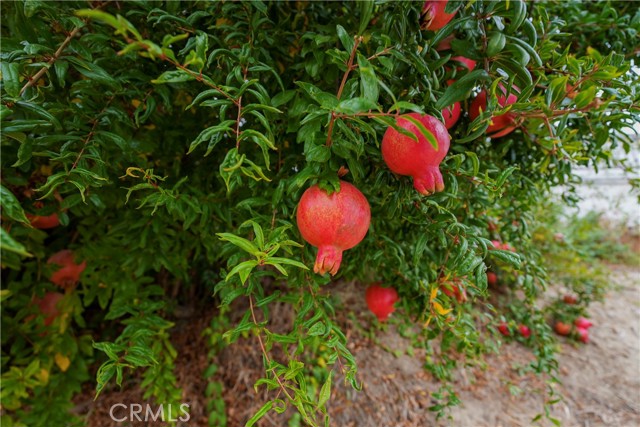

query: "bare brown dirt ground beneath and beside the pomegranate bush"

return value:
[77, 266, 640, 427]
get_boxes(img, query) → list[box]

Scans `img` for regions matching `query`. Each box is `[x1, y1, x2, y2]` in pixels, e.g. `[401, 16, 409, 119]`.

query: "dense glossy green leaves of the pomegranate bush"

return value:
[0, 0, 640, 426]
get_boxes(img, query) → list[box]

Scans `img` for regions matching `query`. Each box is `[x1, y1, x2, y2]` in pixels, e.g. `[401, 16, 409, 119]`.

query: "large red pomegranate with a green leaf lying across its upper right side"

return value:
[381, 113, 450, 195]
